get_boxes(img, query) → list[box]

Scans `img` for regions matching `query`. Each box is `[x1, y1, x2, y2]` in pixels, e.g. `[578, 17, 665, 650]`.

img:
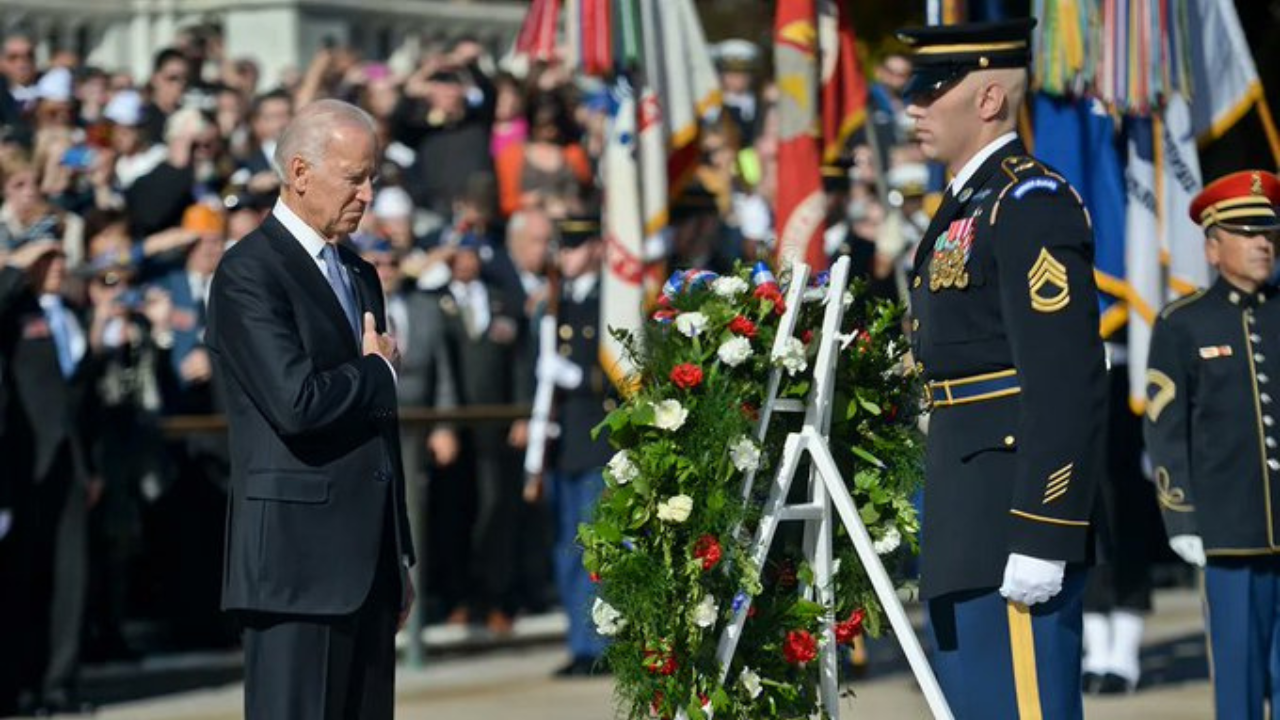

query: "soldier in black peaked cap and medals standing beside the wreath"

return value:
[900, 19, 1106, 720]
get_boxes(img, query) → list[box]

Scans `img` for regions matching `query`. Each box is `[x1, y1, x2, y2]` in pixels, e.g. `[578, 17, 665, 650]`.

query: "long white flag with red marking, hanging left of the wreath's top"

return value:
[600, 87, 644, 393]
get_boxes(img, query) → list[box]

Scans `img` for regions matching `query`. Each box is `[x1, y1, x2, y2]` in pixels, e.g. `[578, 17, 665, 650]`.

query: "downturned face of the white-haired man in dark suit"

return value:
[289, 126, 376, 238]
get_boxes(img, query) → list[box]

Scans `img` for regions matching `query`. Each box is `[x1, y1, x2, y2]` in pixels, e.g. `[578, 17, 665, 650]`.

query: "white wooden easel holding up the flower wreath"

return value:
[680, 256, 952, 720]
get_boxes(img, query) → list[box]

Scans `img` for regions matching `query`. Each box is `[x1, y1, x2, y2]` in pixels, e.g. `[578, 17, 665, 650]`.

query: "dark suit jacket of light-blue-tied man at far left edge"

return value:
[0, 268, 91, 483]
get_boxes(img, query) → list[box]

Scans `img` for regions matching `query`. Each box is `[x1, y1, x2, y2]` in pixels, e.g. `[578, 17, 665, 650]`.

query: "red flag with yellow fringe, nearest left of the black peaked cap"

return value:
[818, 0, 867, 163]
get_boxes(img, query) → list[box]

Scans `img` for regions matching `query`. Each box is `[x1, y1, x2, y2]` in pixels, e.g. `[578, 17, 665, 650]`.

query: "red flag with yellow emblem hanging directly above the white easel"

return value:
[773, 0, 827, 270]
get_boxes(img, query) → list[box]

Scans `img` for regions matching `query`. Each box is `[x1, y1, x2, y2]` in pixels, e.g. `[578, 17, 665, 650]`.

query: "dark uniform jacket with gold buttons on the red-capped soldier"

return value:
[1146, 279, 1280, 557]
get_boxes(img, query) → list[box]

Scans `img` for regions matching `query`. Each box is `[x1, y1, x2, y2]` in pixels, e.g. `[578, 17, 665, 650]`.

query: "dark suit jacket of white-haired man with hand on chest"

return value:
[205, 211, 413, 615]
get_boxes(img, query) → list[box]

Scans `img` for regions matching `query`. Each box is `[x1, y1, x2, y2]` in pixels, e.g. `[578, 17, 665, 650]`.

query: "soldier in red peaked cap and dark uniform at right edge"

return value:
[1146, 170, 1280, 720]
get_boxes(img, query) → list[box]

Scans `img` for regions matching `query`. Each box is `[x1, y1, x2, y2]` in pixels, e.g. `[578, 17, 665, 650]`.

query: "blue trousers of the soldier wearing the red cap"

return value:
[1204, 557, 1280, 720]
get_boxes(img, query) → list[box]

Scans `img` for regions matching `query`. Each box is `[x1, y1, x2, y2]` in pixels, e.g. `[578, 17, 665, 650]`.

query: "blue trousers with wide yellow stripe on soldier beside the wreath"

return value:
[929, 570, 1087, 720]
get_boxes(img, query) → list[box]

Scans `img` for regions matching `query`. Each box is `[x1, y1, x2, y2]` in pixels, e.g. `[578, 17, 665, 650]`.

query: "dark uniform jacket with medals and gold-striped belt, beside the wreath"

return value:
[911, 140, 1107, 598]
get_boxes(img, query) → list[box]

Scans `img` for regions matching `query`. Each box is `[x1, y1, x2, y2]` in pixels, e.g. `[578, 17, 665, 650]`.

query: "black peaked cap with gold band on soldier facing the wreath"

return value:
[897, 18, 1036, 97]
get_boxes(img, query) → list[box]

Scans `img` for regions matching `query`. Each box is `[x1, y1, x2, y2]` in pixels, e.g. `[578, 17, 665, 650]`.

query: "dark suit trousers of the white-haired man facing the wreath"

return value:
[242, 511, 401, 720]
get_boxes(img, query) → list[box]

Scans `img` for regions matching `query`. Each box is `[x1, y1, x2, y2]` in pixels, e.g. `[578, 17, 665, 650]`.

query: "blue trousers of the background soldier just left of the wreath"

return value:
[547, 469, 604, 660]
